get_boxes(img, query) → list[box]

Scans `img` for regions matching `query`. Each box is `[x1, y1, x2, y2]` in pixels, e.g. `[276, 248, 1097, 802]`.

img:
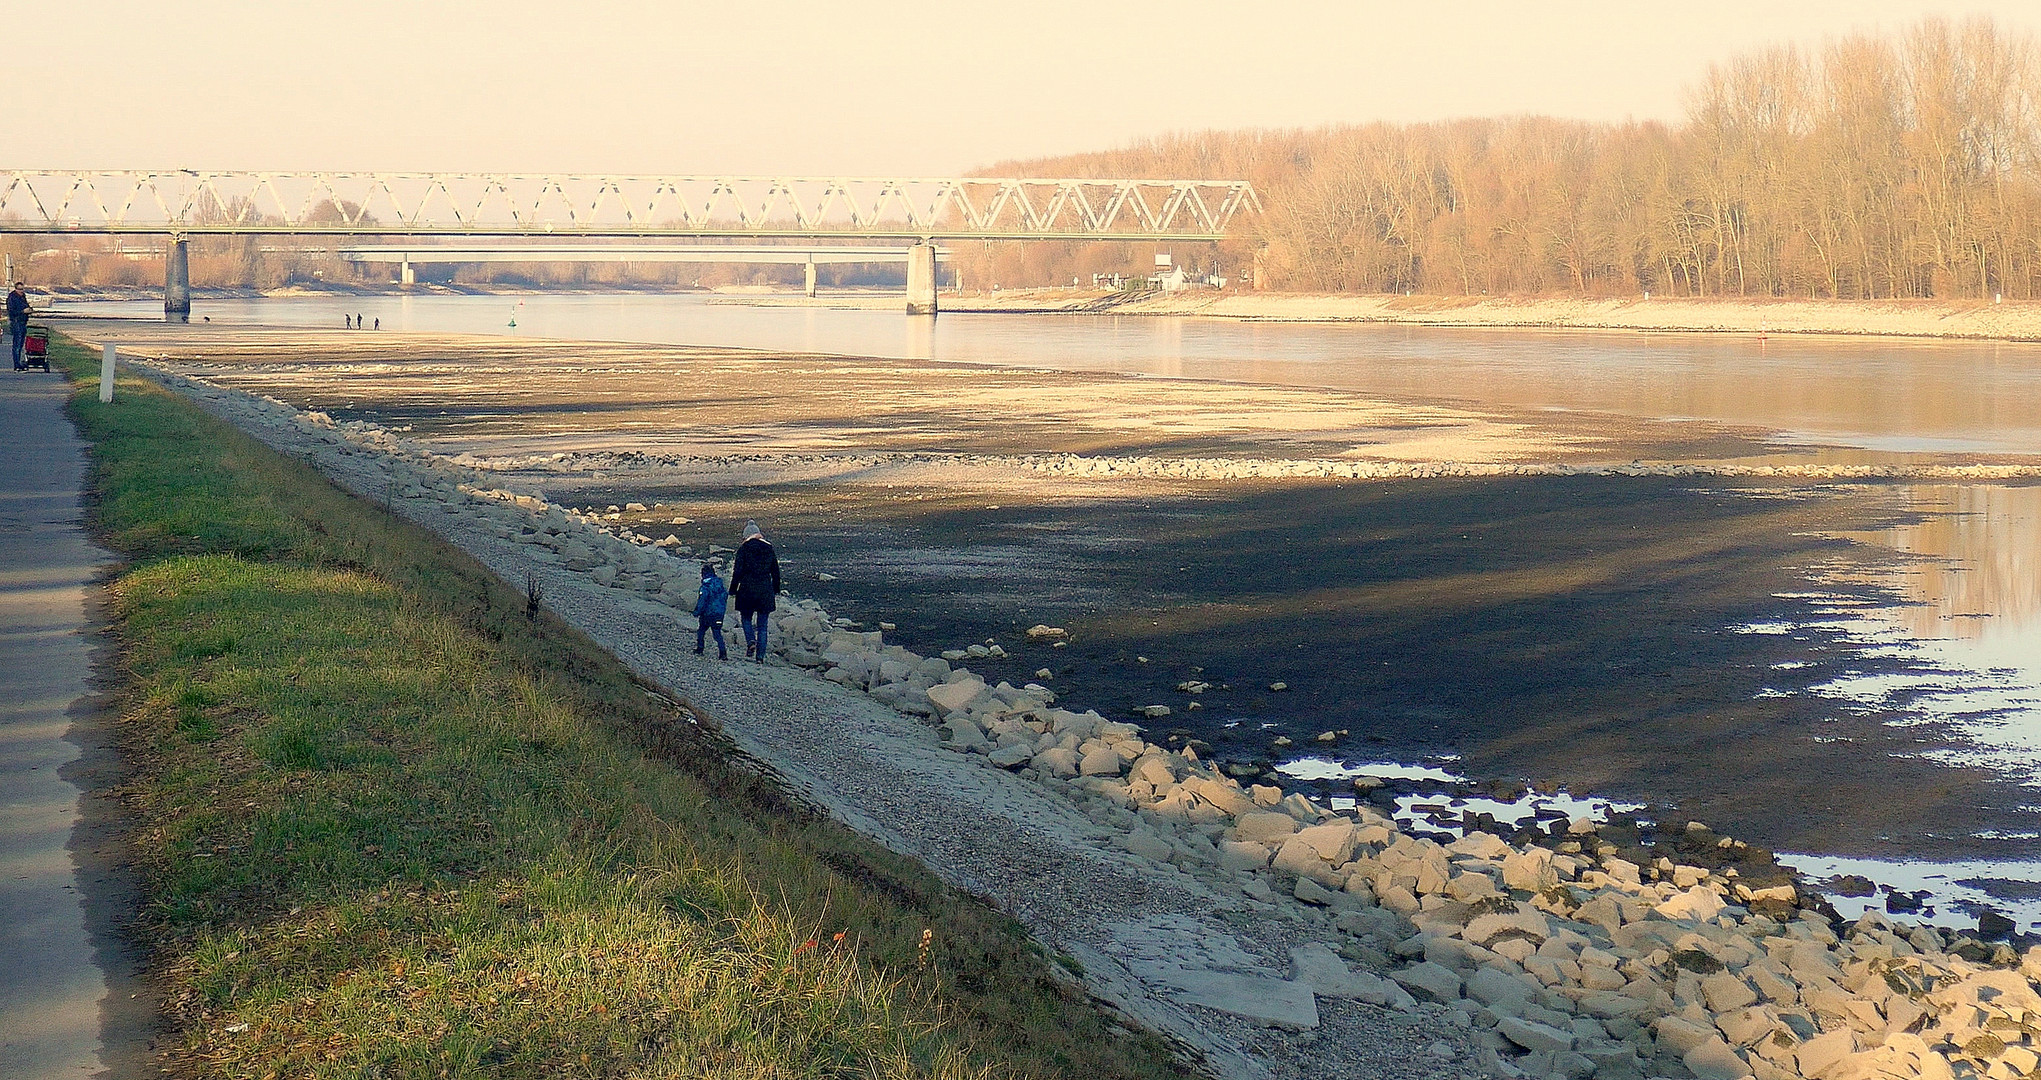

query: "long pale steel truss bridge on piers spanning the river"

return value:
[0, 169, 1261, 318]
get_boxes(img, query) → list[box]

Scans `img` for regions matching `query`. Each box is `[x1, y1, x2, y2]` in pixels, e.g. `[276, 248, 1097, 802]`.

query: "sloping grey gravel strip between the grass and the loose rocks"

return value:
[103, 347, 1494, 1080]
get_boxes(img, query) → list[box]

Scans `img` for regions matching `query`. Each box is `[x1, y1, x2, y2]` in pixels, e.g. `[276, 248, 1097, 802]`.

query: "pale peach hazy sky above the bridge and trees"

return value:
[15, 0, 2041, 176]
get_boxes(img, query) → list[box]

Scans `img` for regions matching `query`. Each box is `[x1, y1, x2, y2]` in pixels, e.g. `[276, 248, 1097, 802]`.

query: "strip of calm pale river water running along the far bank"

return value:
[57, 294, 2041, 455]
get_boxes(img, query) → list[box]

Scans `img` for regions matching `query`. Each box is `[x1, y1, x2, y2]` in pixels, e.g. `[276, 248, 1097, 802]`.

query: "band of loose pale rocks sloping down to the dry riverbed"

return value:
[139, 359, 2041, 1080]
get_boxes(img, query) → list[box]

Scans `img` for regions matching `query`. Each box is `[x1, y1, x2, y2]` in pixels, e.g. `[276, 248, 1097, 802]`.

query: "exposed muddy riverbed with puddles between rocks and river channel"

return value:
[59, 298, 2041, 930]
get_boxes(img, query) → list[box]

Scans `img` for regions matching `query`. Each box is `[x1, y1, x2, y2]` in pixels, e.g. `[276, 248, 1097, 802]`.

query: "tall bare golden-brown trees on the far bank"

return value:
[959, 18, 2041, 298]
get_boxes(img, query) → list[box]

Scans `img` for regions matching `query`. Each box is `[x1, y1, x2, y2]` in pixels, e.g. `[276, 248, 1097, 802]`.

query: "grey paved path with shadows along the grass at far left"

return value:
[0, 367, 147, 1080]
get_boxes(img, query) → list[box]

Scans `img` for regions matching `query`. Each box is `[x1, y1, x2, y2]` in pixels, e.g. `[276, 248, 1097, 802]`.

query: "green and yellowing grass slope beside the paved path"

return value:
[57, 343, 1172, 1078]
